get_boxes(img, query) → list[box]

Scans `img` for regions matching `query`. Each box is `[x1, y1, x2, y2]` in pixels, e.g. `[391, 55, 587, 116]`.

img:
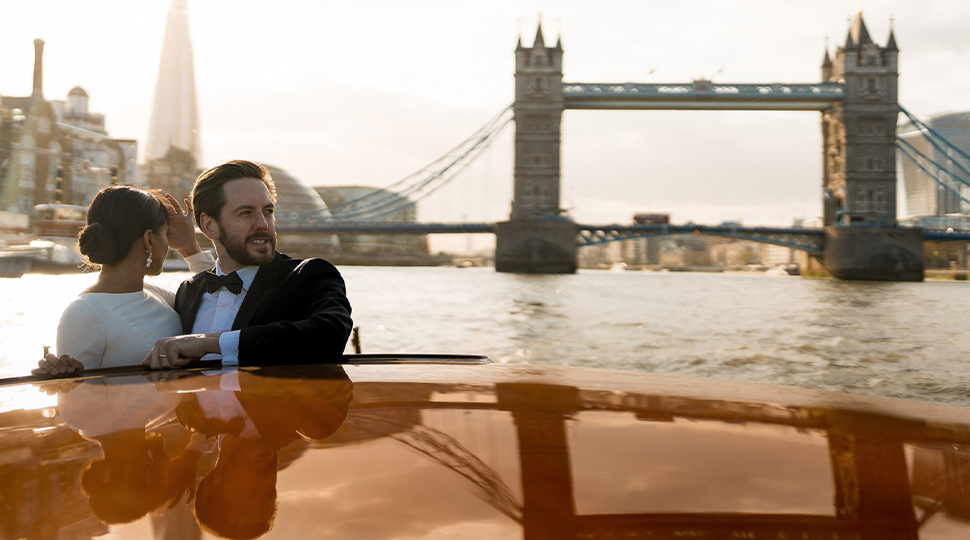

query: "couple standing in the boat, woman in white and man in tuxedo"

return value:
[34, 161, 352, 375]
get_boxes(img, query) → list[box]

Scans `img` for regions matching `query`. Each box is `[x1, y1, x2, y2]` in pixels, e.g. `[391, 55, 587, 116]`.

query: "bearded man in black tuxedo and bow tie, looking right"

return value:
[142, 160, 353, 369]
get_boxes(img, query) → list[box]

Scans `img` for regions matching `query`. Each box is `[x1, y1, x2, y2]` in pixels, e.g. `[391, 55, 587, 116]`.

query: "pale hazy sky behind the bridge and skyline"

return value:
[0, 0, 970, 250]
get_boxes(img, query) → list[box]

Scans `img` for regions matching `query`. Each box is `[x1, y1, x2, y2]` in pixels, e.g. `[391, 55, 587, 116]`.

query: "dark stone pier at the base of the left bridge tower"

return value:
[495, 219, 579, 274]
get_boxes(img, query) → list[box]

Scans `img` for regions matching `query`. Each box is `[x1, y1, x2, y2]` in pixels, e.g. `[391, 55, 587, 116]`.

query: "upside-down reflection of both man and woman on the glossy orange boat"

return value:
[58, 366, 353, 538]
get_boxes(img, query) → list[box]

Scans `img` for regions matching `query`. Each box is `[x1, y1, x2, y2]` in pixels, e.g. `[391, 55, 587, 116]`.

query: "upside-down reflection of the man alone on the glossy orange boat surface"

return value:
[177, 366, 353, 538]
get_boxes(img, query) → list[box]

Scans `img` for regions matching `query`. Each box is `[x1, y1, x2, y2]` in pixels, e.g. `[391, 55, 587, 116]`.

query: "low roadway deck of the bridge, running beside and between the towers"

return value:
[276, 221, 970, 253]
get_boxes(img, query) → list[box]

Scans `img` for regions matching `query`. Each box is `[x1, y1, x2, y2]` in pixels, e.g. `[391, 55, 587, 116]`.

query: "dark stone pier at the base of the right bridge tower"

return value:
[823, 225, 923, 281]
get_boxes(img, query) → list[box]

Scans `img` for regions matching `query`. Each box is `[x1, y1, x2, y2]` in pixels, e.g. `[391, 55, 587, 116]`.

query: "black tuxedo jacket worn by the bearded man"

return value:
[175, 253, 353, 366]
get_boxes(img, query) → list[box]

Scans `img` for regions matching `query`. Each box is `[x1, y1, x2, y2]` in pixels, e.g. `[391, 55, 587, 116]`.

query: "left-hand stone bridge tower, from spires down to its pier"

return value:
[495, 23, 578, 273]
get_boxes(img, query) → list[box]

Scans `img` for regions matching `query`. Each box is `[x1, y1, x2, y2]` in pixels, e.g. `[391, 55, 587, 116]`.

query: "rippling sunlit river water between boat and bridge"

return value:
[0, 267, 970, 406]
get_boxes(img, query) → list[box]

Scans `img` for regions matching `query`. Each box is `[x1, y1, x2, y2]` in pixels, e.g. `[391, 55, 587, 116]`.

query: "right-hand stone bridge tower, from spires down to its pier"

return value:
[822, 12, 923, 281]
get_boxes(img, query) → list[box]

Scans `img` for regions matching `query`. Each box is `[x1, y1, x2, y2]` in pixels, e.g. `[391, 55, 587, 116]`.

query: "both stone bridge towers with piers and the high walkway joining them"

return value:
[495, 13, 923, 281]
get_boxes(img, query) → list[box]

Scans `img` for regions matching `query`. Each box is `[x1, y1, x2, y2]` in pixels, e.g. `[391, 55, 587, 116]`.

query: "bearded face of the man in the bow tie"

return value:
[210, 178, 276, 272]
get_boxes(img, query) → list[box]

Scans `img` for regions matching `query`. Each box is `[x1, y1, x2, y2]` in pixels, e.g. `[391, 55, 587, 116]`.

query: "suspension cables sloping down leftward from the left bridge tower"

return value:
[297, 106, 513, 222]
